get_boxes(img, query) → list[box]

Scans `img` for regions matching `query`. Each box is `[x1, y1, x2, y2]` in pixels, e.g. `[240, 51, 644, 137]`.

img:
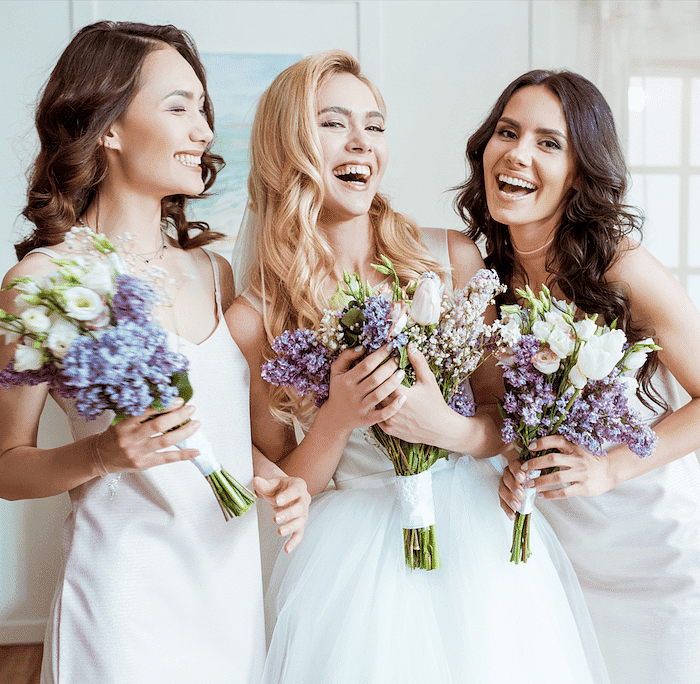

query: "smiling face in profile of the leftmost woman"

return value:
[104, 46, 213, 201]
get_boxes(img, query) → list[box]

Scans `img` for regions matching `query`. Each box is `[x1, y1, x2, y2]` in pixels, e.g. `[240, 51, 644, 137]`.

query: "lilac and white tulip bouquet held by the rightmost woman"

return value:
[494, 286, 660, 563]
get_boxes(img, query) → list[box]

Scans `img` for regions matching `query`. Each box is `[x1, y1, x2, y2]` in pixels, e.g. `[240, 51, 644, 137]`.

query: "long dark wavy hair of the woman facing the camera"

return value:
[454, 69, 666, 408]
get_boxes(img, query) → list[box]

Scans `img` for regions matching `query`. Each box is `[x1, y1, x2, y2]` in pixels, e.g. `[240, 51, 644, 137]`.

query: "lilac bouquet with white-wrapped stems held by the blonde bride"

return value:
[262, 257, 502, 570]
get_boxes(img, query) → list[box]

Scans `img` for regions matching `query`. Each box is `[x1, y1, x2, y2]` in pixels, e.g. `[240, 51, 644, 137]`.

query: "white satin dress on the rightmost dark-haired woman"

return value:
[538, 366, 700, 684]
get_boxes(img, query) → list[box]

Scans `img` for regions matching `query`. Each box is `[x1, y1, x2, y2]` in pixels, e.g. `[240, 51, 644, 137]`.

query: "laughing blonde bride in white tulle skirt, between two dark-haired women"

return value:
[226, 51, 607, 684]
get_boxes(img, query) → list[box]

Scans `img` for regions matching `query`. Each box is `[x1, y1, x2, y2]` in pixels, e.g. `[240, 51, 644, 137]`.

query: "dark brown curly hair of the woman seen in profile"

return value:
[15, 21, 224, 259]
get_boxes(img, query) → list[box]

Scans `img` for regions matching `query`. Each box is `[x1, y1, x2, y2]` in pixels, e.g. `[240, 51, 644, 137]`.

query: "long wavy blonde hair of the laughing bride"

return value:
[248, 50, 445, 422]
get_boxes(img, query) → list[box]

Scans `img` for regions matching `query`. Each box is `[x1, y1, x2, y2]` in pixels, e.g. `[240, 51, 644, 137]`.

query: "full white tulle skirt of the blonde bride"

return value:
[263, 456, 609, 684]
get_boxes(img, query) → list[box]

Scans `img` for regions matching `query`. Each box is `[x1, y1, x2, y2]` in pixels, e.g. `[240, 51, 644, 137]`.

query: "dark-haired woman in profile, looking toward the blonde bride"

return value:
[0, 22, 309, 684]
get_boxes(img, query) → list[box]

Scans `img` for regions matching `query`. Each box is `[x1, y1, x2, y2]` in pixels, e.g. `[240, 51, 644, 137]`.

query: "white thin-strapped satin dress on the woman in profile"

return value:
[30, 249, 265, 684]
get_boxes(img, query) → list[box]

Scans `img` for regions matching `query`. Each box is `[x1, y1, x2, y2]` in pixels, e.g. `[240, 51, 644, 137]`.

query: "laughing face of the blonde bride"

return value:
[317, 73, 388, 224]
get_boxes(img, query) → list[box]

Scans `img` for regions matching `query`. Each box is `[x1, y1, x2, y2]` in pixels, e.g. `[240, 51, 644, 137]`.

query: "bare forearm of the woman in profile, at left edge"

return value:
[0, 437, 100, 501]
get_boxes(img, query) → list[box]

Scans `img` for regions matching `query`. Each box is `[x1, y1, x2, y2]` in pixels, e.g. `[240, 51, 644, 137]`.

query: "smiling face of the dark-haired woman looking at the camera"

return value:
[484, 86, 576, 243]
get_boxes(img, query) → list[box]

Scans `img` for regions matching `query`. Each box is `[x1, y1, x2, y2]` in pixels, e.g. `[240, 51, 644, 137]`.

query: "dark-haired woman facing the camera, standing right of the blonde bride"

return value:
[455, 70, 700, 684]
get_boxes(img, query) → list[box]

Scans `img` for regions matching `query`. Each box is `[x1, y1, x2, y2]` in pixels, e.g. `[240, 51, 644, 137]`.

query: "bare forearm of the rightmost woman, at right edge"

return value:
[608, 397, 700, 486]
